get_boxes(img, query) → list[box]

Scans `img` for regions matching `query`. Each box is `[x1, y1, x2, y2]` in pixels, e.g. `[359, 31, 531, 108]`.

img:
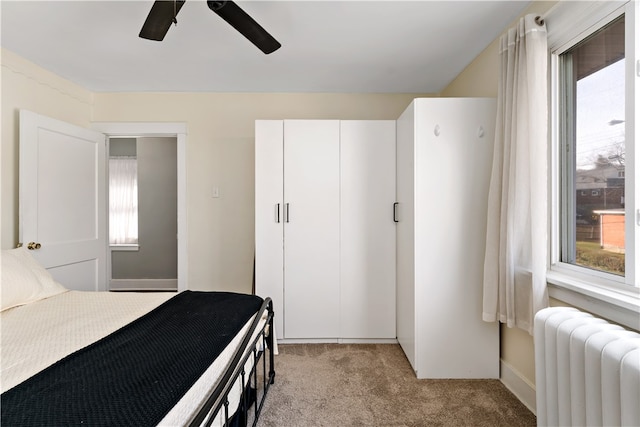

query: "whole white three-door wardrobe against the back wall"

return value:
[255, 120, 396, 340]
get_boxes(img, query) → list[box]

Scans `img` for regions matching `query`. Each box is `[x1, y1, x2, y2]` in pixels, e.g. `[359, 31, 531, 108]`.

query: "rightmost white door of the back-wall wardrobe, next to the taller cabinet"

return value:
[340, 120, 396, 338]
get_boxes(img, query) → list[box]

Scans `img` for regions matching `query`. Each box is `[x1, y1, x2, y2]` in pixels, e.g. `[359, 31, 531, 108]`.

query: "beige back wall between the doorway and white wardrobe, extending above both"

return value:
[92, 93, 430, 292]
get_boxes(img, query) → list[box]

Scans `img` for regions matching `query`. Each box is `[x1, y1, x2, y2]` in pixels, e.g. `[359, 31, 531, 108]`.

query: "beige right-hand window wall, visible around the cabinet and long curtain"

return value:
[441, 1, 556, 398]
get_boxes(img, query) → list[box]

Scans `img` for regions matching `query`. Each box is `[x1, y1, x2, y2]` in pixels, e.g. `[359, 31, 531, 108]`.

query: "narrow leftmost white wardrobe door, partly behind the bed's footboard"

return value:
[255, 120, 284, 338]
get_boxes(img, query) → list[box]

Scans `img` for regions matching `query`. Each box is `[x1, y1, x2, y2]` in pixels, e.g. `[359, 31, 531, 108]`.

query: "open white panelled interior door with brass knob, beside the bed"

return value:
[19, 110, 107, 291]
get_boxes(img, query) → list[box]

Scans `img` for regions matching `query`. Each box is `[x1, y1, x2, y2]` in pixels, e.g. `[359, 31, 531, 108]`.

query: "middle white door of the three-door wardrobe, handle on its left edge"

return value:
[284, 120, 340, 338]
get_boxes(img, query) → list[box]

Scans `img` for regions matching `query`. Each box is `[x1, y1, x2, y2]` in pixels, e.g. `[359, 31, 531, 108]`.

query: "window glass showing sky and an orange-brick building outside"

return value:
[560, 15, 625, 276]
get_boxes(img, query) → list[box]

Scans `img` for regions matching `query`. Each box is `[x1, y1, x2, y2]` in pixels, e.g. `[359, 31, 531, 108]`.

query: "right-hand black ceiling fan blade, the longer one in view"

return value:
[207, 0, 281, 54]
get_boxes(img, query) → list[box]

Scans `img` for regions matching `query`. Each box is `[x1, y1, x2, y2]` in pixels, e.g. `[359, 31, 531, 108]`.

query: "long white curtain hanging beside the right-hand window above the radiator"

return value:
[482, 15, 548, 334]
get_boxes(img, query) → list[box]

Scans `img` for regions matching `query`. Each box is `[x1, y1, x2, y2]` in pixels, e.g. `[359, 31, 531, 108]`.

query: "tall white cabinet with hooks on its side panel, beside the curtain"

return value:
[396, 98, 499, 378]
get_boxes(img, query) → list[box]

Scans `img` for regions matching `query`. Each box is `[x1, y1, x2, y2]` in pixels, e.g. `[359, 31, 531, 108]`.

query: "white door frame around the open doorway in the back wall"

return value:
[91, 122, 188, 292]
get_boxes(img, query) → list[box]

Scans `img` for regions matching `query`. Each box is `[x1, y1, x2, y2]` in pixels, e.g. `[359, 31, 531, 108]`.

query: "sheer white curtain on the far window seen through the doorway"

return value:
[109, 157, 138, 244]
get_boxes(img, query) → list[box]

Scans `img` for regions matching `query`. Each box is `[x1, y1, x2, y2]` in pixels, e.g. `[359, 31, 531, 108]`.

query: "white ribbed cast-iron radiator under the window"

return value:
[533, 307, 640, 426]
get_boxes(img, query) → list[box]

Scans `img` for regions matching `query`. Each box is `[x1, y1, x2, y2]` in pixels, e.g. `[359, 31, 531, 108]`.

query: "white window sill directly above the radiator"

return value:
[547, 270, 640, 330]
